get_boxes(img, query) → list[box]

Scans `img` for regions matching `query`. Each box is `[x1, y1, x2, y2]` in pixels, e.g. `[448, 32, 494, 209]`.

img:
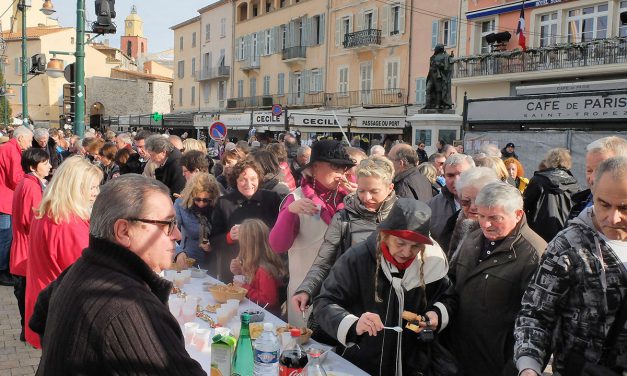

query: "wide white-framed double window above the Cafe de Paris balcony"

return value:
[567, 4, 608, 43]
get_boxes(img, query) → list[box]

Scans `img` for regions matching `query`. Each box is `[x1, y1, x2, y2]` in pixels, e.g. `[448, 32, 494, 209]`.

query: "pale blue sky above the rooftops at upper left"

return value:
[52, 0, 216, 53]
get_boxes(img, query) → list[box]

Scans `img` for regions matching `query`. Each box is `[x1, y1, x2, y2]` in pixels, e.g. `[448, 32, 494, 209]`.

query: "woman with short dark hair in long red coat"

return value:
[9, 148, 52, 341]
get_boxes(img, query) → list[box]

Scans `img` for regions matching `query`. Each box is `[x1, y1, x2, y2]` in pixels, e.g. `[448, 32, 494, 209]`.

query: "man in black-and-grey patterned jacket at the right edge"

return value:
[514, 157, 627, 376]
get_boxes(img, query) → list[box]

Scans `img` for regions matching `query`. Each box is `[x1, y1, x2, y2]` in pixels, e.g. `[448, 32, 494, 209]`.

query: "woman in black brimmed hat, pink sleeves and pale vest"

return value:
[270, 140, 355, 327]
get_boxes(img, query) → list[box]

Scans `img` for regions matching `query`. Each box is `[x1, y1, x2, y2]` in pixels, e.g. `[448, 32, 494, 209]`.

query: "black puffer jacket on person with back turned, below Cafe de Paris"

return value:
[523, 168, 579, 242]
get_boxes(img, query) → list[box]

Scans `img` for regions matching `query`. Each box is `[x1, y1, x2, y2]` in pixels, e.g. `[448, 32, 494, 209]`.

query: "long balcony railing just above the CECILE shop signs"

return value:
[227, 89, 407, 109]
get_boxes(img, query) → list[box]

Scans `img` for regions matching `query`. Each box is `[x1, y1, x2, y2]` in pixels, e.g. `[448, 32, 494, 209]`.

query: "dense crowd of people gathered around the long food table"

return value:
[0, 126, 627, 376]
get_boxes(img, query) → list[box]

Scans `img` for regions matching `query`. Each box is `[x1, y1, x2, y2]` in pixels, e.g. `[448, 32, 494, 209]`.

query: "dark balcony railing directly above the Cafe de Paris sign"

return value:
[454, 37, 627, 78]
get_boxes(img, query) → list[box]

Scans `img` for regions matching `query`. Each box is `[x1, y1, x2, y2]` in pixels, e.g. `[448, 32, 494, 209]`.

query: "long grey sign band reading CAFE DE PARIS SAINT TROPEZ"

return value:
[467, 93, 627, 122]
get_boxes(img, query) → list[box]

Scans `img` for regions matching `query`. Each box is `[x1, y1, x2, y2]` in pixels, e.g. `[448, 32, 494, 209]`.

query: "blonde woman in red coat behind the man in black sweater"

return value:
[24, 156, 103, 348]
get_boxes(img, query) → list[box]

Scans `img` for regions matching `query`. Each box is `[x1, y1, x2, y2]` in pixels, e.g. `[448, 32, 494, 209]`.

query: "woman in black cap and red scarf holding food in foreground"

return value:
[314, 198, 454, 376]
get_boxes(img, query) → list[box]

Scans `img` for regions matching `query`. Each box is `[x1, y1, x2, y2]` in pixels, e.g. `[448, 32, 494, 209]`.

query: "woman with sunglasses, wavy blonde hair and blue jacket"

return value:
[174, 172, 220, 273]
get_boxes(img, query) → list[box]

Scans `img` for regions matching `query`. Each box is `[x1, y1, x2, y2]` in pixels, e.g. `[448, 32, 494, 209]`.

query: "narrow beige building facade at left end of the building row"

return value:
[170, 16, 201, 112]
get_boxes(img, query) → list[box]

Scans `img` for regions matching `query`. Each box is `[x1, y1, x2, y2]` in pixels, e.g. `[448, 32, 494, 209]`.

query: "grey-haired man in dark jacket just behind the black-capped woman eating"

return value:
[428, 154, 475, 249]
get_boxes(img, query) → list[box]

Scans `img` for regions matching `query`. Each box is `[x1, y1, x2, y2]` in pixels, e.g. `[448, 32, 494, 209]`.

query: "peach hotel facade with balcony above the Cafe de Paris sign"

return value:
[453, 0, 627, 113]
